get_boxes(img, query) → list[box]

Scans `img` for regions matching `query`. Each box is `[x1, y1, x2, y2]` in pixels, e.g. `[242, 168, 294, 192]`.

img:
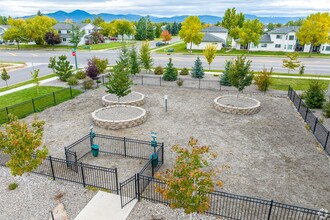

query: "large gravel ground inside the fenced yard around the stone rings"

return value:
[1, 83, 330, 219]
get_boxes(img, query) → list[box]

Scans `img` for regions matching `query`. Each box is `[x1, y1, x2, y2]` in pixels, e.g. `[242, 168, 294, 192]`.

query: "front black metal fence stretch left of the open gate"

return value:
[0, 154, 119, 194]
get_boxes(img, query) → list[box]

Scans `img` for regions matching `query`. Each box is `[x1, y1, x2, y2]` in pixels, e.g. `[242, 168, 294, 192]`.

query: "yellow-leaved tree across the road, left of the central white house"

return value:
[179, 16, 203, 52]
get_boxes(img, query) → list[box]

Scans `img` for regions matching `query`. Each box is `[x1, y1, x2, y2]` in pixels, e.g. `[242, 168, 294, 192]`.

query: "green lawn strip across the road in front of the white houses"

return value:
[155, 42, 330, 58]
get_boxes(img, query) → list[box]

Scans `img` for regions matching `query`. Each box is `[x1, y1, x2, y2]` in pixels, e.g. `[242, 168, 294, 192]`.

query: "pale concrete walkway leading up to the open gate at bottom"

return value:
[74, 191, 137, 220]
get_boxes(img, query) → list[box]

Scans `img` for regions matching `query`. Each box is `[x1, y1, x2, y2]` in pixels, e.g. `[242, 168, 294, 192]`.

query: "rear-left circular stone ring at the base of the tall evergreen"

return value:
[102, 92, 144, 106]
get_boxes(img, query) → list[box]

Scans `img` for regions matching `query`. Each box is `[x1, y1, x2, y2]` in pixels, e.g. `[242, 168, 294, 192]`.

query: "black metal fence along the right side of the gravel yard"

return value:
[288, 86, 330, 155]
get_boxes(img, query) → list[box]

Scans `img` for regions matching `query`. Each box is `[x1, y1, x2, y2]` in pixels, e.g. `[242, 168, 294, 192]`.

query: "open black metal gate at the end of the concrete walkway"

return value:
[119, 175, 138, 208]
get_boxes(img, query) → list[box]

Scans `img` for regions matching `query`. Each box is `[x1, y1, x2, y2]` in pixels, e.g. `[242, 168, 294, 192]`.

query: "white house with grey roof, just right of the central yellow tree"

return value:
[186, 26, 228, 50]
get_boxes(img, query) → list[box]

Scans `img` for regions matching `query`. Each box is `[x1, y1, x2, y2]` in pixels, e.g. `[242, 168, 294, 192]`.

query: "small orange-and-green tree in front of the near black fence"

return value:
[155, 138, 223, 219]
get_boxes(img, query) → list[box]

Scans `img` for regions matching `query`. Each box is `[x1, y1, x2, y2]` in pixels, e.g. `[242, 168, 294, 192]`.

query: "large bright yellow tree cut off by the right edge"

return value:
[297, 12, 330, 54]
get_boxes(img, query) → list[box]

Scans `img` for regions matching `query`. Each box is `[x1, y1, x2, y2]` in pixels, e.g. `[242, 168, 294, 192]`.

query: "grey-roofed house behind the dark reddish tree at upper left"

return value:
[53, 23, 102, 45]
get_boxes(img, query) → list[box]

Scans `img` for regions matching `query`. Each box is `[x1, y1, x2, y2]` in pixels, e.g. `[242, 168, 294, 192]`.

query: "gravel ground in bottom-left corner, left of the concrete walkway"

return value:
[0, 166, 96, 220]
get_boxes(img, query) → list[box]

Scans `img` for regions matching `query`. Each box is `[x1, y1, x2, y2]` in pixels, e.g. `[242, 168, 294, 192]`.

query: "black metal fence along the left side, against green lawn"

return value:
[0, 87, 76, 124]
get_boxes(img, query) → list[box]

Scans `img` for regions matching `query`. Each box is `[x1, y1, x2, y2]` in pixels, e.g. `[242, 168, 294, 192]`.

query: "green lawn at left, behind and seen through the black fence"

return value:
[0, 86, 81, 124]
